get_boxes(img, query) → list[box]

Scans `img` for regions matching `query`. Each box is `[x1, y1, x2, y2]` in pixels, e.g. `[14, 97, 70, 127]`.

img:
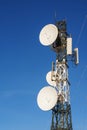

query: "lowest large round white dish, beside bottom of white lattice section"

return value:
[37, 86, 58, 111]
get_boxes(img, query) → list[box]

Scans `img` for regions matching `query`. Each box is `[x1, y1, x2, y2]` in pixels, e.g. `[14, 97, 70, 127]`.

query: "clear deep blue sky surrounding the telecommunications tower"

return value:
[0, 0, 87, 130]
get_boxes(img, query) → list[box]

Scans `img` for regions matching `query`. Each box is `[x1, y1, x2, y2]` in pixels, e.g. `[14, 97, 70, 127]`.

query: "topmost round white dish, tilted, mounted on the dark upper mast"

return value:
[39, 24, 58, 46]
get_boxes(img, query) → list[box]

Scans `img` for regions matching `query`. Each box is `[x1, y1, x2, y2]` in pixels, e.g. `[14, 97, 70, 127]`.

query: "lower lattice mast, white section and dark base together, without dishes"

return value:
[51, 61, 72, 130]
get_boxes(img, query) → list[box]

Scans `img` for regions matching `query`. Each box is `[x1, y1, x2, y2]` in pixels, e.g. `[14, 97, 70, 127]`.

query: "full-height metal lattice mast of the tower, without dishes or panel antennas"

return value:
[51, 21, 72, 130]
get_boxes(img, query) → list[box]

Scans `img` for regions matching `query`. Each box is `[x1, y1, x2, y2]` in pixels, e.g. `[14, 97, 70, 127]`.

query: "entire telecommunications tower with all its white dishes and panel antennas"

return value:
[37, 20, 79, 130]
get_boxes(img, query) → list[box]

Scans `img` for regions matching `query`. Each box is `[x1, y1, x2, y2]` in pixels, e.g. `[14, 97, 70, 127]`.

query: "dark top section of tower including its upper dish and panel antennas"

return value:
[39, 20, 79, 65]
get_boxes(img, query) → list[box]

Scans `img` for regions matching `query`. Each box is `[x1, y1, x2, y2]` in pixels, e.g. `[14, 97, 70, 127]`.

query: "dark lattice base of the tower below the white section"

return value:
[50, 102, 73, 130]
